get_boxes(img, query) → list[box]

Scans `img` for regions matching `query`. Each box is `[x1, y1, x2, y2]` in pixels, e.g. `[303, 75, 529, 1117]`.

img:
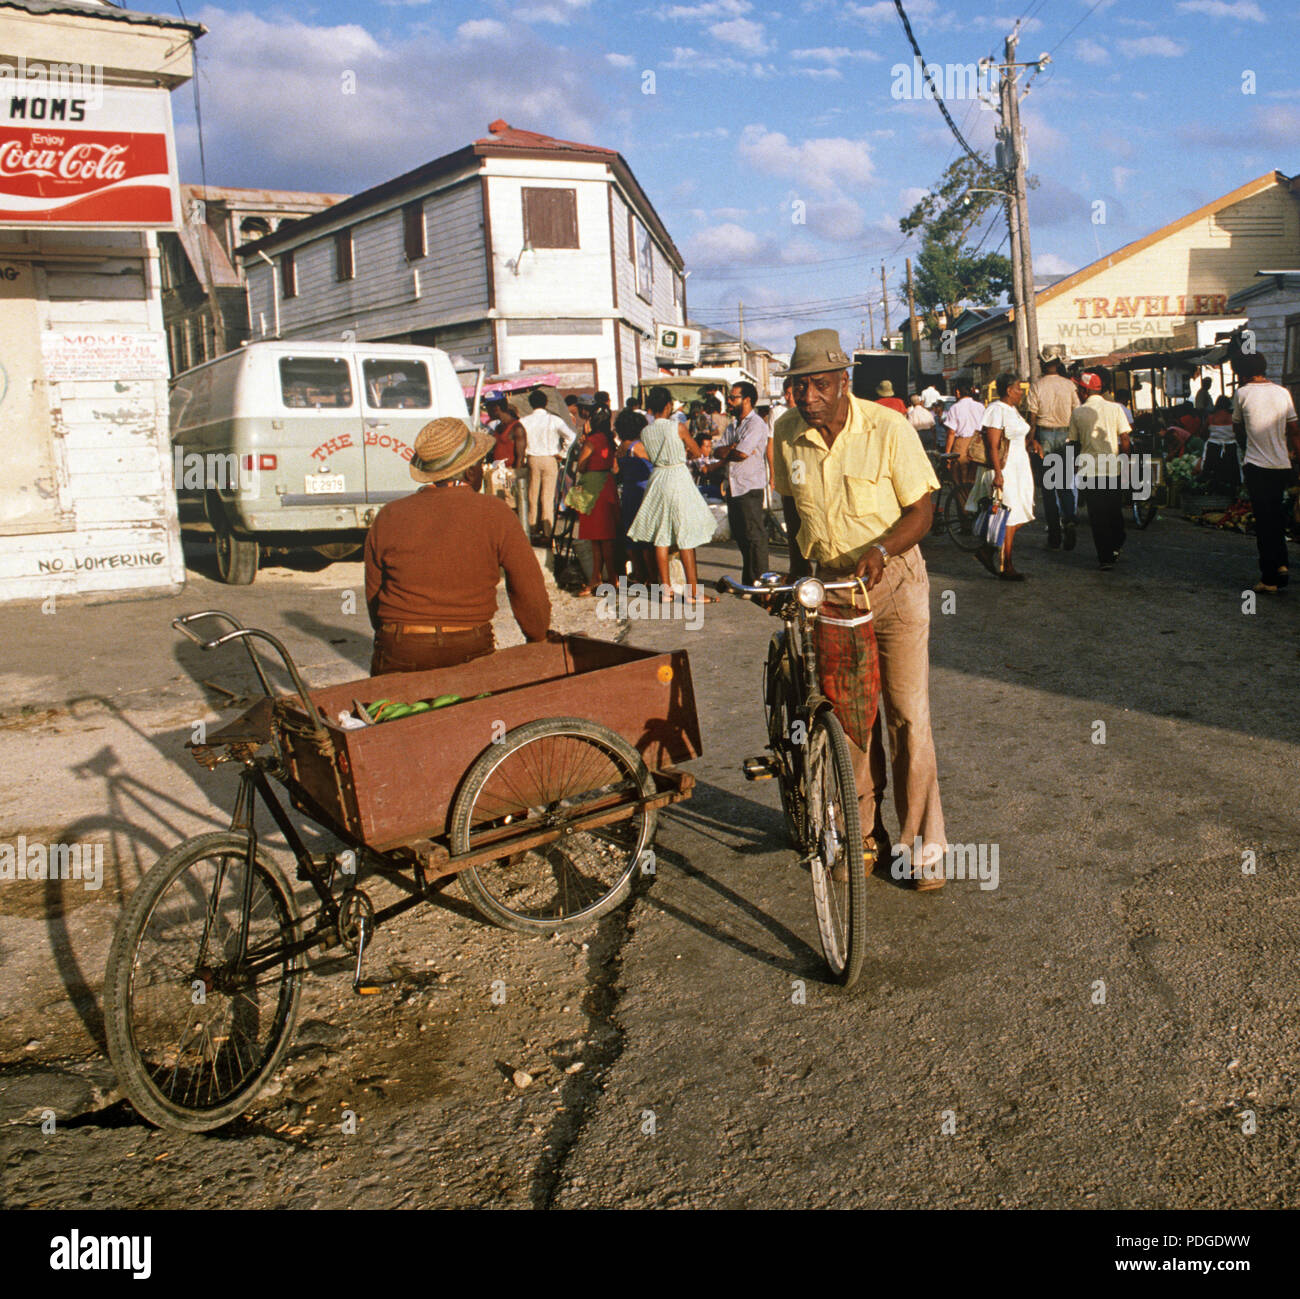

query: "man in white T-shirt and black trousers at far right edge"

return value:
[1232, 352, 1300, 593]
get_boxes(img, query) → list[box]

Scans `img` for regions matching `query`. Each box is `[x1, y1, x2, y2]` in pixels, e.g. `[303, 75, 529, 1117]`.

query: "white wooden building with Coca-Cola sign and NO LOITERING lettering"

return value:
[0, 0, 203, 612]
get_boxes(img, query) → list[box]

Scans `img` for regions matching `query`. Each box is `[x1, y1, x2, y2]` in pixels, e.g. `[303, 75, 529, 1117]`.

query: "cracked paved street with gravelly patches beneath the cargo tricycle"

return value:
[0, 518, 1300, 1208]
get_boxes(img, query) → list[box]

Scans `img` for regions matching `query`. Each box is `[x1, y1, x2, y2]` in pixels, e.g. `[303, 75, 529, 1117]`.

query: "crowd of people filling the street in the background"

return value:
[475, 343, 1294, 602]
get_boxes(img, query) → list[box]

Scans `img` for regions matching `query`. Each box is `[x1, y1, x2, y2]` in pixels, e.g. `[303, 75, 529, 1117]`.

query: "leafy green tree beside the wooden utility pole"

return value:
[898, 155, 1011, 334]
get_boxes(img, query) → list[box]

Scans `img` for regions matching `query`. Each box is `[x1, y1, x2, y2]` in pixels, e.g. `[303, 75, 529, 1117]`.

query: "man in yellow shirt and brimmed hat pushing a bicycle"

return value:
[774, 329, 946, 888]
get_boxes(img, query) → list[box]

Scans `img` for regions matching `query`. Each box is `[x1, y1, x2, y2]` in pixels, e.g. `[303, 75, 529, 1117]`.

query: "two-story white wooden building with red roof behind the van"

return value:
[239, 121, 686, 400]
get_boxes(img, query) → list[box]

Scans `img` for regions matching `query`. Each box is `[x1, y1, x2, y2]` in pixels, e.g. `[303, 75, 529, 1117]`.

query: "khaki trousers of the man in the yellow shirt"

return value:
[827, 546, 948, 871]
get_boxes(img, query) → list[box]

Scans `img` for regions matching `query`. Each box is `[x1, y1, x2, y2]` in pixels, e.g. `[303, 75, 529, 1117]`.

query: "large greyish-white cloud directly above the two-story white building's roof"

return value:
[174, 4, 595, 192]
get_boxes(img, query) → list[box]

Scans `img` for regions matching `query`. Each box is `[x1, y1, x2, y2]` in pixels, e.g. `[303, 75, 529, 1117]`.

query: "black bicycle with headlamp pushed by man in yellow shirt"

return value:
[718, 573, 871, 987]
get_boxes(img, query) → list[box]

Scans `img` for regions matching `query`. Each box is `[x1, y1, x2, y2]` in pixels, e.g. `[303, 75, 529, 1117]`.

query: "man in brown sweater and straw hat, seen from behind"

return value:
[365, 419, 551, 676]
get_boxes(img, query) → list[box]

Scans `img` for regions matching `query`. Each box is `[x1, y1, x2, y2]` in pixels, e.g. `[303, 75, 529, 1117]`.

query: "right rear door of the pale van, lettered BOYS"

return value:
[358, 351, 436, 505]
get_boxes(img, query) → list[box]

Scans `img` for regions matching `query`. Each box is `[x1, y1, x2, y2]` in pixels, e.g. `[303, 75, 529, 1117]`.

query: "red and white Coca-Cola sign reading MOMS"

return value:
[0, 78, 179, 230]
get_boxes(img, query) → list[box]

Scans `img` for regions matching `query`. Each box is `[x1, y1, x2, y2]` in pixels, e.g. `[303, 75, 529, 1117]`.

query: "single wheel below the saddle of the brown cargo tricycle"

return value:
[104, 831, 303, 1133]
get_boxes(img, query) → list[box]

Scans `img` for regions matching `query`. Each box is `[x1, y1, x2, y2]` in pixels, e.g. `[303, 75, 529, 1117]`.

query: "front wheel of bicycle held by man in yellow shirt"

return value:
[806, 711, 867, 987]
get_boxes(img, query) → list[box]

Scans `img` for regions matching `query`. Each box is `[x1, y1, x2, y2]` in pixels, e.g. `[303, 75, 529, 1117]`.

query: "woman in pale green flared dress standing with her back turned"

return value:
[628, 386, 718, 605]
